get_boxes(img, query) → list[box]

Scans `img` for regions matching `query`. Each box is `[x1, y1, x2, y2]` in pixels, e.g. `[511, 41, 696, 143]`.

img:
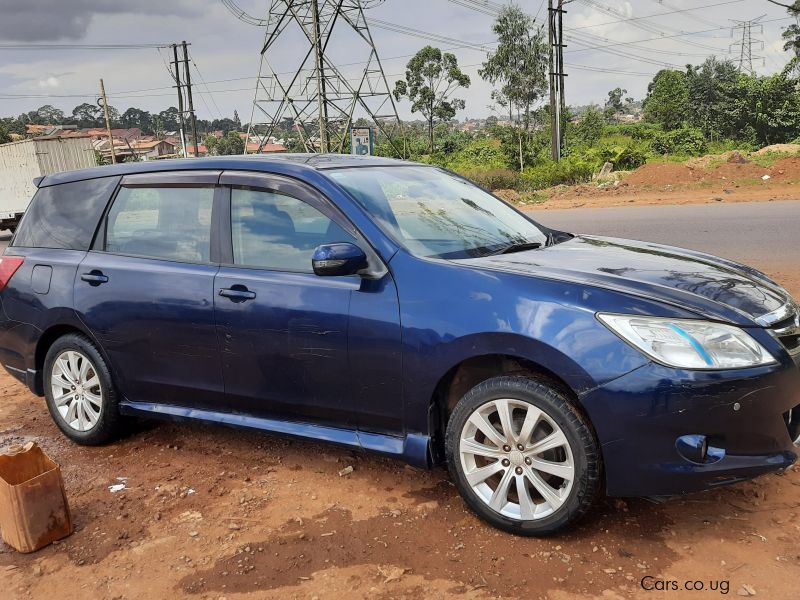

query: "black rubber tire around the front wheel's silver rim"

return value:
[445, 376, 602, 536]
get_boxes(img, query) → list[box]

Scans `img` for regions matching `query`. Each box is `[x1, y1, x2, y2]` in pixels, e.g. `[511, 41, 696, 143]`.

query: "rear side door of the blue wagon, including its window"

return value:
[74, 171, 224, 408]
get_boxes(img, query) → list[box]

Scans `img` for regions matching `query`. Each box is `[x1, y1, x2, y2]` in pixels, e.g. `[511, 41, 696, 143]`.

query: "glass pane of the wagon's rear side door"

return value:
[105, 187, 214, 262]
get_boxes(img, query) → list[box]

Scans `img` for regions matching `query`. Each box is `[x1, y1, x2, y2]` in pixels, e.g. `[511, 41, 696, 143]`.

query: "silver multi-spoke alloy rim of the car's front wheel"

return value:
[459, 398, 575, 521]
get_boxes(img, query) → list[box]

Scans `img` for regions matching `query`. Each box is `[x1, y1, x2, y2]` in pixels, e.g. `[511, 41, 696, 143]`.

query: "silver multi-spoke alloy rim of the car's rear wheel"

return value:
[50, 350, 103, 431]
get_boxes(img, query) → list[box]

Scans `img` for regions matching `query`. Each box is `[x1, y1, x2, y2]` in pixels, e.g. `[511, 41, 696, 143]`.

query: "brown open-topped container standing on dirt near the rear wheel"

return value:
[0, 442, 72, 552]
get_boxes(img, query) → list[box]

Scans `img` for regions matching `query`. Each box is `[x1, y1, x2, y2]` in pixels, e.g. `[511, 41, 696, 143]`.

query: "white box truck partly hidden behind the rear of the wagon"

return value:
[0, 137, 97, 231]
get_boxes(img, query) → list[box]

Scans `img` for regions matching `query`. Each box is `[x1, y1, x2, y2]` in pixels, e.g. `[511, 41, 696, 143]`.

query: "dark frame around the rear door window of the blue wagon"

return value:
[94, 171, 224, 265]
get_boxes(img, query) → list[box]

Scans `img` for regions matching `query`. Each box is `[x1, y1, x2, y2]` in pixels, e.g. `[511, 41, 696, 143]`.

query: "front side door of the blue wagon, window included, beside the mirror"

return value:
[214, 173, 400, 429]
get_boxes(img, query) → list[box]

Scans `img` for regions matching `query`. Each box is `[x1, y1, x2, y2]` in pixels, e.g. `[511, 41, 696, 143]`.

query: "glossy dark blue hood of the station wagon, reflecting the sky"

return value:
[465, 236, 791, 323]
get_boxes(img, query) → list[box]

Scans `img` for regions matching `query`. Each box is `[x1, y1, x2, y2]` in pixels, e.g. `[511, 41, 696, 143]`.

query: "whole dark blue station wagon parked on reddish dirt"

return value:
[0, 155, 800, 535]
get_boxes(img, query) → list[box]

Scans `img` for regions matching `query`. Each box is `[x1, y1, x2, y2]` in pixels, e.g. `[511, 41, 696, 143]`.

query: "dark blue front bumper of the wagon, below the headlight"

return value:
[581, 363, 800, 496]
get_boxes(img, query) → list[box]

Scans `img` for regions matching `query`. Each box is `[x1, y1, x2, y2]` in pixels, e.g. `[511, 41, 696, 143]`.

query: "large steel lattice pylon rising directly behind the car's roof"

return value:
[222, 0, 402, 155]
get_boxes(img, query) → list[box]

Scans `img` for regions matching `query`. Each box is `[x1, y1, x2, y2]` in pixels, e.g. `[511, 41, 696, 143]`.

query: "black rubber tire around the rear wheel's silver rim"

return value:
[43, 333, 123, 446]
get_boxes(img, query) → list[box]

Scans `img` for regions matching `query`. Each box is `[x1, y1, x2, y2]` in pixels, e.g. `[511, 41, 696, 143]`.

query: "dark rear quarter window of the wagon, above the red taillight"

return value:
[12, 177, 119, 250]
